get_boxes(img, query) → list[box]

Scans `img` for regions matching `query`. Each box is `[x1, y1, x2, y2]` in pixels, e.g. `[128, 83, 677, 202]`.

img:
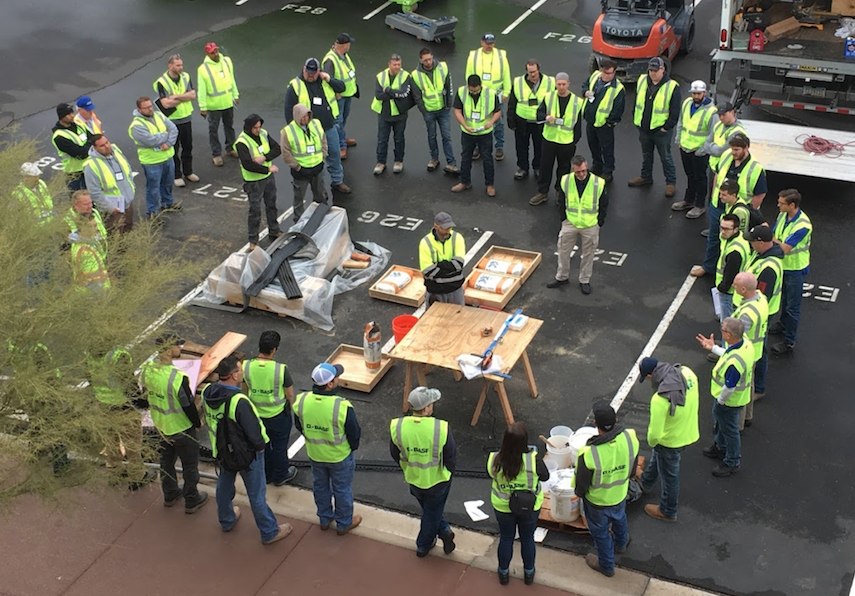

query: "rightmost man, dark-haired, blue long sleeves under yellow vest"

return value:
[772, 188, 813, 355]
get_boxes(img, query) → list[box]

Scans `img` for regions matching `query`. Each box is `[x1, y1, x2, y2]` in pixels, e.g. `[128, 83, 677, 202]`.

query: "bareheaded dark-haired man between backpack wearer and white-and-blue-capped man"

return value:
[243, 331, 297, 486]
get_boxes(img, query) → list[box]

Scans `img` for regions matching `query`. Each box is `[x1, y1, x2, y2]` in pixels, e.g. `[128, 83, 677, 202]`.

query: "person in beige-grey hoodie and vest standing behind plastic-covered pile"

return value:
[279, 103, 328, 222]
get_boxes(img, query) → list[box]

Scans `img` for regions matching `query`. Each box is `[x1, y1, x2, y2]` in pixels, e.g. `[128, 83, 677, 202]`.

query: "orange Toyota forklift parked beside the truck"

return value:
[588, 0, 695, 83]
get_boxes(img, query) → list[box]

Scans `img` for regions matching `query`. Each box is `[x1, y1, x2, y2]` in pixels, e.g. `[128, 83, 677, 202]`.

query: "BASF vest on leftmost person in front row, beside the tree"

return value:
[140, 361, 193, 437]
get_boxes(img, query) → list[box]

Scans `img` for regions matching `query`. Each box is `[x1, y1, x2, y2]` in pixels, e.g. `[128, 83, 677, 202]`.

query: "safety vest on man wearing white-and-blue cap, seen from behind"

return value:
[294, 391, 353, 464]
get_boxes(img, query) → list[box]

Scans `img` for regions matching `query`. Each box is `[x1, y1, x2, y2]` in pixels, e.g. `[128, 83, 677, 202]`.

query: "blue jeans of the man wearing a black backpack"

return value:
[217, 452, 279, 542]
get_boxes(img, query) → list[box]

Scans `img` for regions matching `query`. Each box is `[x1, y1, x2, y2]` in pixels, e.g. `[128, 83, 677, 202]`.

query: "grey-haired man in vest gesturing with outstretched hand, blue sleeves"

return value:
[696, 317, 754, 478]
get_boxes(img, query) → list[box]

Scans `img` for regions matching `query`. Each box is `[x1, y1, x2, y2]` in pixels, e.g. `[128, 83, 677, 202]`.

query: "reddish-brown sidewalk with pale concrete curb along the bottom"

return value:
[0, 484, 716, 596]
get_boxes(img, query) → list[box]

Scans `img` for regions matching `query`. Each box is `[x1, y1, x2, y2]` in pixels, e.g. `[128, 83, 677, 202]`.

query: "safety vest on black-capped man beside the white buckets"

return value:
[578, 428, 639, 507]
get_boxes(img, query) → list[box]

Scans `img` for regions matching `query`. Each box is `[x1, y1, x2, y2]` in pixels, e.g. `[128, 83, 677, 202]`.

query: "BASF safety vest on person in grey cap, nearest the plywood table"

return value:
[389, 416, 451, 489]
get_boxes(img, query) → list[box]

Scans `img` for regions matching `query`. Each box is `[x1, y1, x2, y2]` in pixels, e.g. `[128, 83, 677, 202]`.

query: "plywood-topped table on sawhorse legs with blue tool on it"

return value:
[389, 302, 543, 426]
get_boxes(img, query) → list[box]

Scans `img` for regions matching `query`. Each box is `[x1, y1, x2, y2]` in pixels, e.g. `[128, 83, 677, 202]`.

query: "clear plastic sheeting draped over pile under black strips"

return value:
[200, 203, 391, 331]
